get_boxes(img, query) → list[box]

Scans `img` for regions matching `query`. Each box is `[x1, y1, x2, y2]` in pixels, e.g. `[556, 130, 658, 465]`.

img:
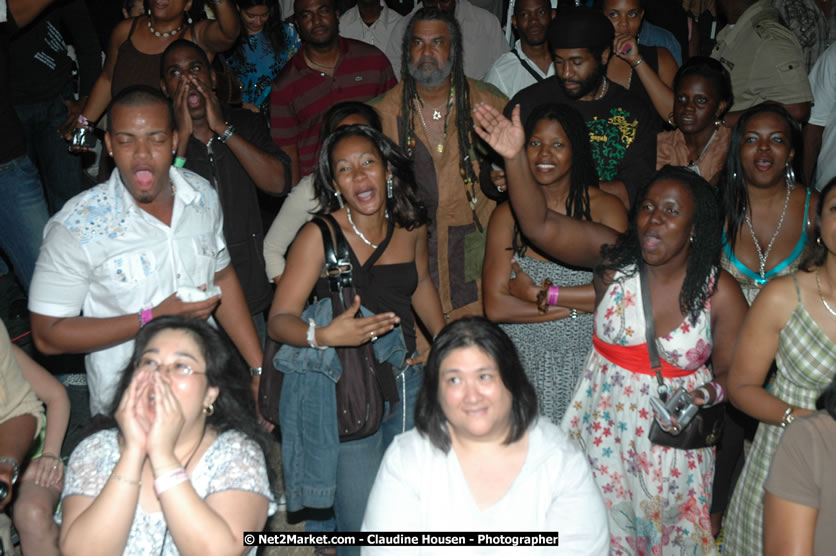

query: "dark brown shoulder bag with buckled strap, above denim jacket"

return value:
[313, 214, 398, 442]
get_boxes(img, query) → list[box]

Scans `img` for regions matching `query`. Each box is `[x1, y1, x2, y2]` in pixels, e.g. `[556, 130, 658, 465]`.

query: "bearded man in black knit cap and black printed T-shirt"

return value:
[505, 8, 658, 207]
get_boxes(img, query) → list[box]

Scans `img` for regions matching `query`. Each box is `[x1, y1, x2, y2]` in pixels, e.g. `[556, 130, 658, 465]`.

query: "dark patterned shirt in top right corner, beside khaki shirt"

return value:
[772, 0, 836, 71]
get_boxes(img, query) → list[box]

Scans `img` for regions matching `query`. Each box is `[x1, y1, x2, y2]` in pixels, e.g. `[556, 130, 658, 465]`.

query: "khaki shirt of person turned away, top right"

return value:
[711, 0, 813, 112]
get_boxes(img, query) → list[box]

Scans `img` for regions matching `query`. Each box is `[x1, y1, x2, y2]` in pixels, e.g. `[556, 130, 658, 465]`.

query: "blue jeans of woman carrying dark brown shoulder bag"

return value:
[334, 365, 424, 555]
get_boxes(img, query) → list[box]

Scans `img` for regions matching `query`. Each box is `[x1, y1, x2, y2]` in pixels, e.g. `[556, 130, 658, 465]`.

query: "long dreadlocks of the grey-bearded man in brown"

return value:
[398, 8, 478, 215]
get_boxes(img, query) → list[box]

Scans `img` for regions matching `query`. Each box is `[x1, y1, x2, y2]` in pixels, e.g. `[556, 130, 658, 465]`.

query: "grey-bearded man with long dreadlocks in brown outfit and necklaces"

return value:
[372, 8, 506, 334]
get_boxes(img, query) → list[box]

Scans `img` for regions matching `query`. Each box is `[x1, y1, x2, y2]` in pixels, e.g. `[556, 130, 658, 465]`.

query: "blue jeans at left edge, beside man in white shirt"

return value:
[0, 152, 49, 293]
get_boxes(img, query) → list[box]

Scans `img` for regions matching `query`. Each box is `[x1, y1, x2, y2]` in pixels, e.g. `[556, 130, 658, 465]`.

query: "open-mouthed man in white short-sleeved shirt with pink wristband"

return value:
[29, 86, 262, 415]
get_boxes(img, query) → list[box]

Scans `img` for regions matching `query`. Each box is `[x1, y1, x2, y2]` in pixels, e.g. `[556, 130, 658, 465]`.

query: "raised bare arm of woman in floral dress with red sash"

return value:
[474, 104, 618, 268]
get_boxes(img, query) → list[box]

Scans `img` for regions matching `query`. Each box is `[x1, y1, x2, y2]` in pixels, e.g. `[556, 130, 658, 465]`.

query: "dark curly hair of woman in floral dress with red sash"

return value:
[595, 165, 722, 324]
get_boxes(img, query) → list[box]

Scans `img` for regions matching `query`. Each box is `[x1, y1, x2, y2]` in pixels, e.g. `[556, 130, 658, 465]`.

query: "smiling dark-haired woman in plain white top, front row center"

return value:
[362, 317, 609, 556]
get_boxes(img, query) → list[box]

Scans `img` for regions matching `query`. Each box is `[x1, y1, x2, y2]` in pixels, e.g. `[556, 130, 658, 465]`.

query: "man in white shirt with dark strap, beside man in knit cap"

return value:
[484, 0, 554, 98]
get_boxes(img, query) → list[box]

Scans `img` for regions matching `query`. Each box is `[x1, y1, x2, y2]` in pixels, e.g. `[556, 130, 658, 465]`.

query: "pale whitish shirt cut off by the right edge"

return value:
[808, 44, 836, 191]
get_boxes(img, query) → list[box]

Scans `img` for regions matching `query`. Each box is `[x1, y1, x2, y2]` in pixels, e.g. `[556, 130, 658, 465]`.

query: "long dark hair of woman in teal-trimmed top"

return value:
[720, 104, 803, 251]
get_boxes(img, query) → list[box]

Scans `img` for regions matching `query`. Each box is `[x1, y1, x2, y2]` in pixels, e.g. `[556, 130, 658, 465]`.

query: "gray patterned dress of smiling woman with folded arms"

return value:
[500, 244, 592, 425]
